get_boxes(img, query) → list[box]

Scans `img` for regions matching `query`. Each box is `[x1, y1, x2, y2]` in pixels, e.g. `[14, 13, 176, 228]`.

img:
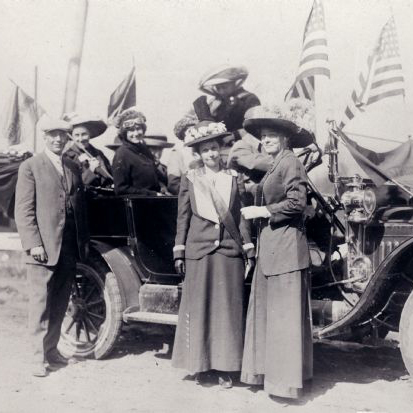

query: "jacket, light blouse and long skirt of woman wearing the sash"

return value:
[172, 168, 253, 374]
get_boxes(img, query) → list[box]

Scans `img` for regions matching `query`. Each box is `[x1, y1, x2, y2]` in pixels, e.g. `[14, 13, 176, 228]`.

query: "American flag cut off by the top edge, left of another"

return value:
[285, 0, 330, 101]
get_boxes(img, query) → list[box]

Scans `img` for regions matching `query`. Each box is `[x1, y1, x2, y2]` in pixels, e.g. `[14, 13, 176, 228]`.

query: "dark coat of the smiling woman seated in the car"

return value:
[112, 142, 161, 195]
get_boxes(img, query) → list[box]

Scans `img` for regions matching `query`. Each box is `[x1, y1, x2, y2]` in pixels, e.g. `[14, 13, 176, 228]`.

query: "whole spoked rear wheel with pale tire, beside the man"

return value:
[59, 253, 124, 359]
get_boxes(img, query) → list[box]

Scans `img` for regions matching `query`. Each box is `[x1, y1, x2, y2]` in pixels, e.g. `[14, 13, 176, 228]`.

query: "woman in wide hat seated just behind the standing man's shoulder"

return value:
[65, 114, 113, 187]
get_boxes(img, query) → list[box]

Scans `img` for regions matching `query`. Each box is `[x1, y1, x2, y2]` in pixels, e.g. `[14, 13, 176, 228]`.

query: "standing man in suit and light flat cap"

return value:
[15, 119, 88, 377]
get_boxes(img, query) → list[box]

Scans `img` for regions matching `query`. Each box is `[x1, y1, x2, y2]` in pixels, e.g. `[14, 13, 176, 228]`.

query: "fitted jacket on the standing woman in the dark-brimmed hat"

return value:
[256, 150, 309, 275]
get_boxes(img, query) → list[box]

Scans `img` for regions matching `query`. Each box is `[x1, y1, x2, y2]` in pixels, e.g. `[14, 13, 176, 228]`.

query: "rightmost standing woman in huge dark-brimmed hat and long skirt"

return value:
[241, 101, 314, 398]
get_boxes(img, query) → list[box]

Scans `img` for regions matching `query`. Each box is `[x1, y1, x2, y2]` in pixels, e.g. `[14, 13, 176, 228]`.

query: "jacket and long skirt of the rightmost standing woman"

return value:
[241, 150, 313, 398]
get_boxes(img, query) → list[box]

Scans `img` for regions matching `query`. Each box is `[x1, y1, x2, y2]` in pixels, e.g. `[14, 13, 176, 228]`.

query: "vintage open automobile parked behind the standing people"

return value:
[3, 131, 413, 374]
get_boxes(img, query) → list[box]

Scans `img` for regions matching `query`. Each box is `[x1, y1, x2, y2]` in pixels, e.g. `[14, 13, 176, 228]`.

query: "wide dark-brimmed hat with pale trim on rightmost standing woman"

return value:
[243, 99, 315, 148]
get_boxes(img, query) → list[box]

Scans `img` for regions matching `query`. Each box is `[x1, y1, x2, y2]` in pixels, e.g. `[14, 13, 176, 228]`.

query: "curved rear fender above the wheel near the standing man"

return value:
[91, 240, 142, 308]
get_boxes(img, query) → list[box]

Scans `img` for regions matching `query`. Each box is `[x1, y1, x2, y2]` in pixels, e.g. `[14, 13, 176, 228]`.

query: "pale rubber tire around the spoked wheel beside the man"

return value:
[59, 252, 124, 359]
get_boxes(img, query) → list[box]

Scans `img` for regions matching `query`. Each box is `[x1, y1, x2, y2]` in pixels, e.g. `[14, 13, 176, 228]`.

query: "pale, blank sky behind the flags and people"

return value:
[0, 0, 413, 149]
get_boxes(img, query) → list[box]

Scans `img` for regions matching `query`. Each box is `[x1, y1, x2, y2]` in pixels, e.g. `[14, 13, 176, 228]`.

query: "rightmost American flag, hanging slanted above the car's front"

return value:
[340, 16, 405, 128]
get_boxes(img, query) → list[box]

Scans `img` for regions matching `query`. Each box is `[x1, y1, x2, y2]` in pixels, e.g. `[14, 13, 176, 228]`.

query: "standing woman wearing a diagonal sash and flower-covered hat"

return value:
[172, 122, 254, 388]
